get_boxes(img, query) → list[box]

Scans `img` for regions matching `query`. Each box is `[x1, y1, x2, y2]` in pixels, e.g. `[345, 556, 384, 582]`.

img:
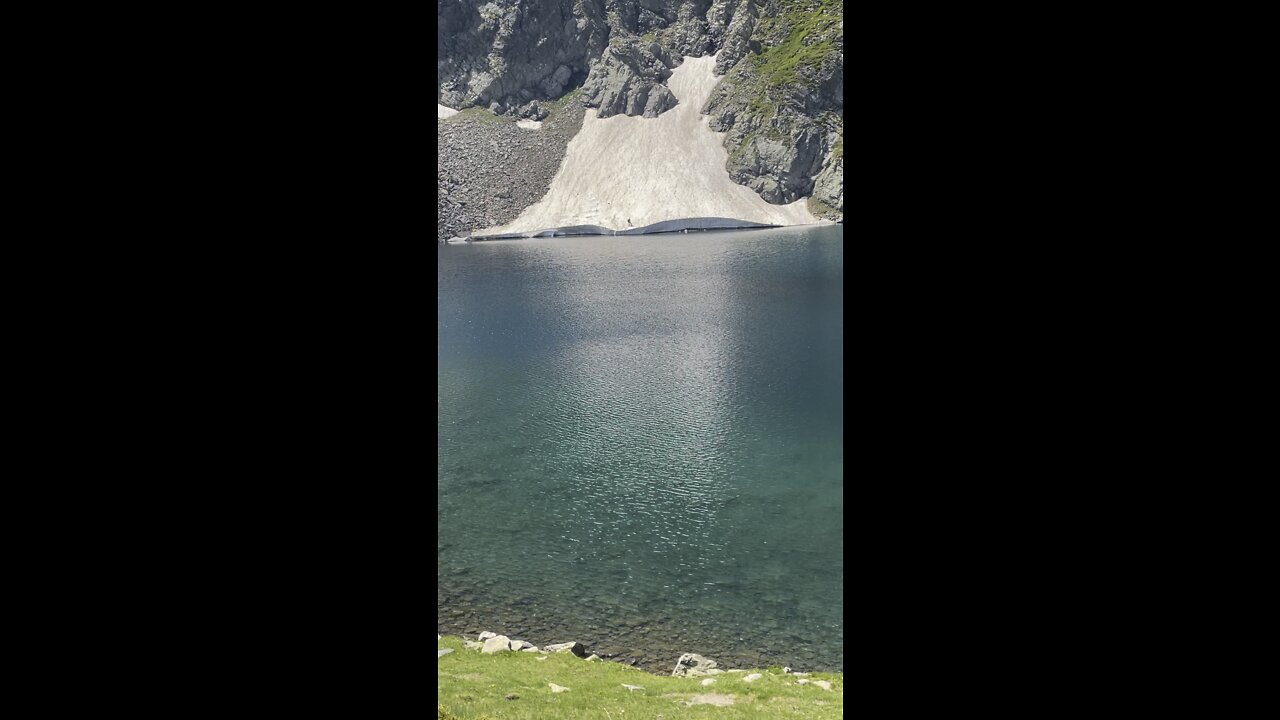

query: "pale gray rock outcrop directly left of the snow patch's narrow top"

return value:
[582, 38, 678, 118]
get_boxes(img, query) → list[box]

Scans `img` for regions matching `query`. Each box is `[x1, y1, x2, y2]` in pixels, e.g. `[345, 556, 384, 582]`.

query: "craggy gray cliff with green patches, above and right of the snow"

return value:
[436, 0, 844, 218]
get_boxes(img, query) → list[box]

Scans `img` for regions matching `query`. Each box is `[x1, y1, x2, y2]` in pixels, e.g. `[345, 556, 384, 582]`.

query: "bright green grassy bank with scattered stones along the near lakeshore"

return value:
[435, 638, 845, 720]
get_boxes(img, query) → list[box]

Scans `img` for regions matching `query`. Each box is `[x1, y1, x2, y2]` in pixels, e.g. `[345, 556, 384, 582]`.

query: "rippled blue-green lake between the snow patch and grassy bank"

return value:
[436, 225, 844, 673]
